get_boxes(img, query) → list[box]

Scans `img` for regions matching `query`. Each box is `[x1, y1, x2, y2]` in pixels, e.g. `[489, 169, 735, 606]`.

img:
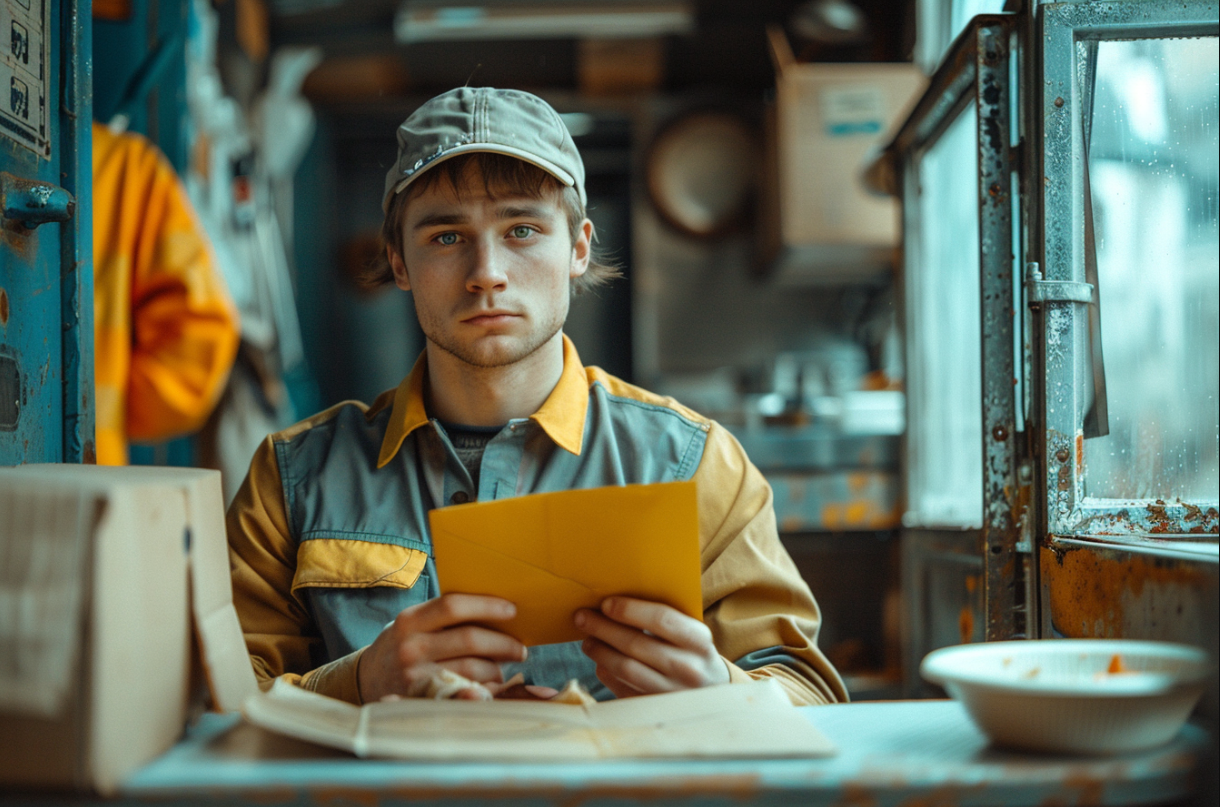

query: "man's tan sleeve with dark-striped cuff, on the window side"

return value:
[694, 424, 847, 704]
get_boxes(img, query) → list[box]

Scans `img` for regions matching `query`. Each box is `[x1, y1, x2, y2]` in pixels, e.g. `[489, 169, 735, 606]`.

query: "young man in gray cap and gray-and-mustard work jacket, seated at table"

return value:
[228, 88, 845, 703]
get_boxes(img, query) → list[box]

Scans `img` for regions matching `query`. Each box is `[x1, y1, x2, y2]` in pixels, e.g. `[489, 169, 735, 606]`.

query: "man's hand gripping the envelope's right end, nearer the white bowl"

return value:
[575, 597, 728, 697]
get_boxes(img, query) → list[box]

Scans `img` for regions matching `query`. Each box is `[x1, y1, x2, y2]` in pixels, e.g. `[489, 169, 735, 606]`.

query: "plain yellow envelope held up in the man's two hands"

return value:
[428, 482, 703, 646]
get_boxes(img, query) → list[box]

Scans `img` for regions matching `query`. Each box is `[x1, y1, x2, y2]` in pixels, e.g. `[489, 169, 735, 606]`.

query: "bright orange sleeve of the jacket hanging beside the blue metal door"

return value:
[117, 136, 239, 441]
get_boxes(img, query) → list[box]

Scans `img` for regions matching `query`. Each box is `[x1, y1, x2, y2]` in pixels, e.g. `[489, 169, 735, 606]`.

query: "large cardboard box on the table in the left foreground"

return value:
[0, 465, 257, 795]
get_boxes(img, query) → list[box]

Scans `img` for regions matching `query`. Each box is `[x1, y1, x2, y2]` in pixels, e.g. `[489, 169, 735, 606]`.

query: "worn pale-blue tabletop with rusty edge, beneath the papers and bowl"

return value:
[16, 701, 1208, 807]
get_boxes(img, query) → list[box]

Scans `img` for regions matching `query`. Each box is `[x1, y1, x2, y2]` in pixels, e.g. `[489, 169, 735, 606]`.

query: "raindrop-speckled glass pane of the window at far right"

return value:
[1085, 37, 1220, 501]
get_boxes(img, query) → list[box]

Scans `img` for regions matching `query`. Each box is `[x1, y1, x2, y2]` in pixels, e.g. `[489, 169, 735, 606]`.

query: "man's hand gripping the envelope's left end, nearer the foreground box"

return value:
[357, 595, 526, 703]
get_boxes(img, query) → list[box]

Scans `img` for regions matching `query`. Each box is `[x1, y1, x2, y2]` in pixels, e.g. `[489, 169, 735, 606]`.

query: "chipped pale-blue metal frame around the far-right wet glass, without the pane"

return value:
[1027, 0, 1220, 538]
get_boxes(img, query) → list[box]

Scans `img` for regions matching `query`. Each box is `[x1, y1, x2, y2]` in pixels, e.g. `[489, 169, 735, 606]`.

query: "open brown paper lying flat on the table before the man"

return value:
[244, 681, 834, 762]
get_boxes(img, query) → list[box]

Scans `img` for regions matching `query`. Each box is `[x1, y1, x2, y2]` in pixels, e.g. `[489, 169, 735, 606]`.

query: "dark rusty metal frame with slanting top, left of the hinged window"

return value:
[866, 13, 1037, 652]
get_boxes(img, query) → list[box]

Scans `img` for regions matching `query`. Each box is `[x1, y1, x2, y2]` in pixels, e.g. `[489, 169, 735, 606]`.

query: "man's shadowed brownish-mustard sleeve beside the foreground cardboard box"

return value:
[227, 437, 362, 703]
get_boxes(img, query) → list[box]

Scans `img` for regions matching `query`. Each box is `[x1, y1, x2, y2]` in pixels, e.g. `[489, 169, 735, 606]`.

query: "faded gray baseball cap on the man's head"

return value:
[382, 87, 587, 210]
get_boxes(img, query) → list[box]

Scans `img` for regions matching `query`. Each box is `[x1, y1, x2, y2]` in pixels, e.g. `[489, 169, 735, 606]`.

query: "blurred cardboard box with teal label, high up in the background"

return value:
[767, 28, 927, 254]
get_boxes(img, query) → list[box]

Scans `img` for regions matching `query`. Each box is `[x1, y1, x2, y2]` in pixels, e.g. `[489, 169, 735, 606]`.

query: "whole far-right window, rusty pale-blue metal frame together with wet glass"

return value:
[1030, 0, 1220, 542]
